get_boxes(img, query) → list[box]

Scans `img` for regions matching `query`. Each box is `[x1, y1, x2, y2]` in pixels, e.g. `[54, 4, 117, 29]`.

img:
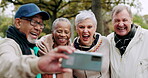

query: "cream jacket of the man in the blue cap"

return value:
[0, 38, 42, 78]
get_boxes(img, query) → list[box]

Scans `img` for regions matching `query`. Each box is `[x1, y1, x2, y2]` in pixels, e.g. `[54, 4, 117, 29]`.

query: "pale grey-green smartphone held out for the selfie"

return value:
[62, 50, 102, 72]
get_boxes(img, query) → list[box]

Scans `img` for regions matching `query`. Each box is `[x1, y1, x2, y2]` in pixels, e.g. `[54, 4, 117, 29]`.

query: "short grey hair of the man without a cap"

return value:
[111, 5, 132, 18]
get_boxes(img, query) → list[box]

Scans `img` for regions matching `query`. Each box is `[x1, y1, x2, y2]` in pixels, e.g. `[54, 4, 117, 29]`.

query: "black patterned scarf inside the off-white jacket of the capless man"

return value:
[114, 24, 136, 56]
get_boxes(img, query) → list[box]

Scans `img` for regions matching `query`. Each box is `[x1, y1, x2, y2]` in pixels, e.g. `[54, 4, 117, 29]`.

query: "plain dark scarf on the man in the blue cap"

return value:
[6, 26, 35, 55]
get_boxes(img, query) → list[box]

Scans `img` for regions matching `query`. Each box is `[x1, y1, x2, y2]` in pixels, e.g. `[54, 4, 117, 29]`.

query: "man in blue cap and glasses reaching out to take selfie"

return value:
[0, 3, 75, 78]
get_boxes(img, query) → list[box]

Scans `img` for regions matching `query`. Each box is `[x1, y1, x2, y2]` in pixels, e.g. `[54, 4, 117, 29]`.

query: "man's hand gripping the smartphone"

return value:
[38, 46, 75, 73]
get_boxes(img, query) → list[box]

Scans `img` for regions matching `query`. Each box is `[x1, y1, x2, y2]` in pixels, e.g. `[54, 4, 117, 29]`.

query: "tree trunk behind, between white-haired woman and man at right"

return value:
[92, 0, 104, 35]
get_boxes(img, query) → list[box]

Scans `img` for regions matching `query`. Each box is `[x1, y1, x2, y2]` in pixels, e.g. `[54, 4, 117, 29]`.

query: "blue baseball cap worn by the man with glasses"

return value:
[15, 3, 49, 20]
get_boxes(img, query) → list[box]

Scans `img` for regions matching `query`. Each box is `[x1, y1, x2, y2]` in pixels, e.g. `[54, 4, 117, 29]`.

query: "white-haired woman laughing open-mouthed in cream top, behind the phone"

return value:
[73, 10, 110, 78]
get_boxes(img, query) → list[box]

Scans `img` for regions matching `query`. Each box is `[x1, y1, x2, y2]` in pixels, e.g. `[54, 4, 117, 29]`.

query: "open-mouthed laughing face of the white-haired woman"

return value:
[76, 19, 96, 46]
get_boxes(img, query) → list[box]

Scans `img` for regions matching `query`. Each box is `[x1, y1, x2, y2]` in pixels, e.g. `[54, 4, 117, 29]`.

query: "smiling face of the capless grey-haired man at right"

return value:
[112, 10, 132, 36]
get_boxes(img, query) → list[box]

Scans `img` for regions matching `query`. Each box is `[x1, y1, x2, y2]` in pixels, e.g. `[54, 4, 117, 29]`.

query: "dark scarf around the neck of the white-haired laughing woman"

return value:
[74, 34, 99, 51]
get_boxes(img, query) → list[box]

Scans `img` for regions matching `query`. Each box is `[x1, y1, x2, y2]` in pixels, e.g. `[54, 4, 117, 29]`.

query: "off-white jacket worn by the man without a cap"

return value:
[108, 26, 148, 78]
